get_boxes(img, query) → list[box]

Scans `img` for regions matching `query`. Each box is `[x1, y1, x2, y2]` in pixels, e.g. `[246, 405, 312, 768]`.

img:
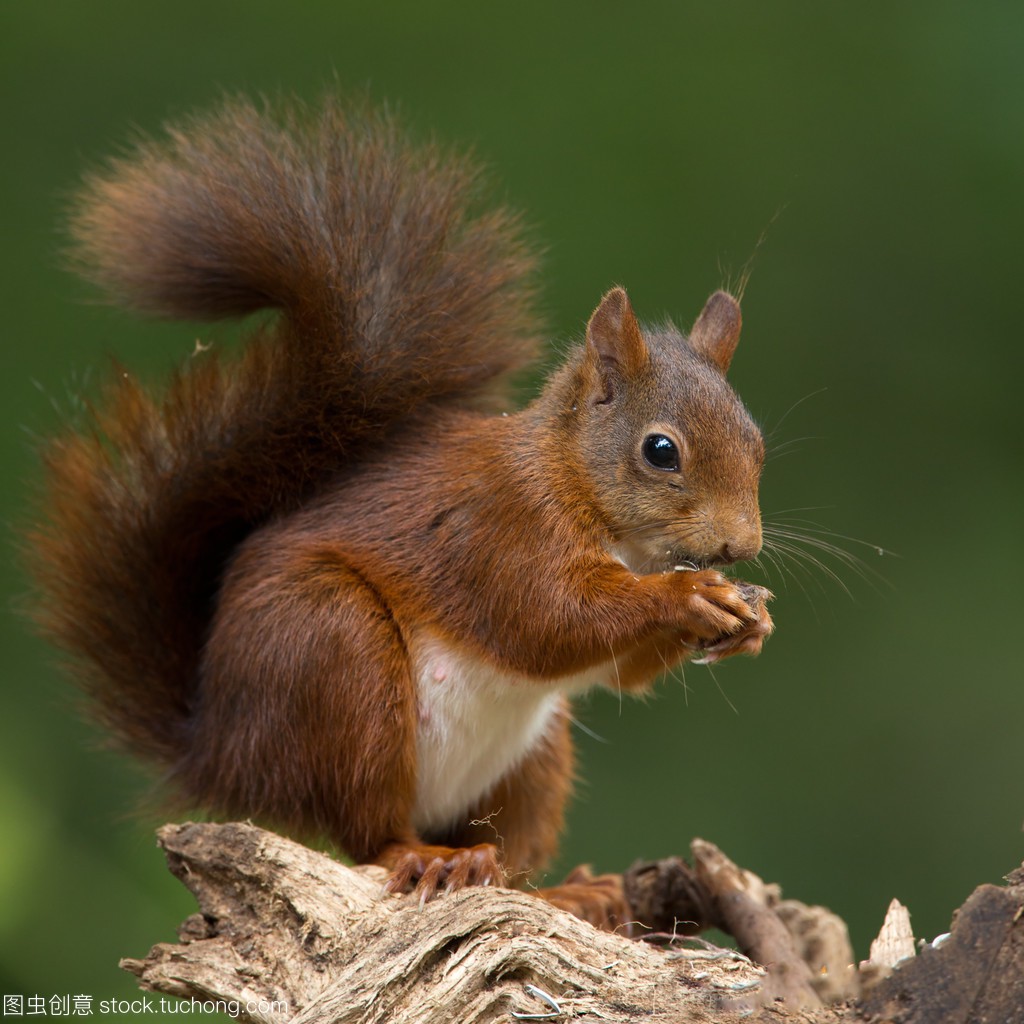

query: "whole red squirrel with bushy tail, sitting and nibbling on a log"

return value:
[32, 99, 772, 924]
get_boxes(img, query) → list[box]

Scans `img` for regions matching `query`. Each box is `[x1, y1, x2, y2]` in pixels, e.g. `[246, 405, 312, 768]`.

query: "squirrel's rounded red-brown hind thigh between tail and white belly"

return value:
[189, 537, 417, 862]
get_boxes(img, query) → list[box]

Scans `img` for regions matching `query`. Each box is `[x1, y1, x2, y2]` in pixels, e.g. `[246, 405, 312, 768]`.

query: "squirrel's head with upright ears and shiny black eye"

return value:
[571, 288, 764, 571]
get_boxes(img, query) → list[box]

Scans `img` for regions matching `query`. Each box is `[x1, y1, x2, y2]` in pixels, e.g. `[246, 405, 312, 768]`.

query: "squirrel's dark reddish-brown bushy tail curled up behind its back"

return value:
[30, 94, 537, 765]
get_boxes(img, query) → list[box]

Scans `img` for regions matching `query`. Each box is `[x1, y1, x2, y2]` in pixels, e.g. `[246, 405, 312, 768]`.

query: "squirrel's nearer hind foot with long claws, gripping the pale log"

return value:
[378, 843, 505, 903]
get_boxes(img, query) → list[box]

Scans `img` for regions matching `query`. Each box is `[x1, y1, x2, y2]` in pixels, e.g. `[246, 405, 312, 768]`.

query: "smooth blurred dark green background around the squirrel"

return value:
[0, 0, 1024, 1000]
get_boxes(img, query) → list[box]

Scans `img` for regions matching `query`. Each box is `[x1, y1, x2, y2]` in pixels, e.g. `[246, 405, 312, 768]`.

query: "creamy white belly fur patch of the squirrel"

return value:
[412, 637, 614, 831]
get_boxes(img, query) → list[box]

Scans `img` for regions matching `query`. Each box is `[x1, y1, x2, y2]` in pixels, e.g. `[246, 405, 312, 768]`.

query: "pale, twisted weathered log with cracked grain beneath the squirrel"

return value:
[123, 824, 764, 1024]
